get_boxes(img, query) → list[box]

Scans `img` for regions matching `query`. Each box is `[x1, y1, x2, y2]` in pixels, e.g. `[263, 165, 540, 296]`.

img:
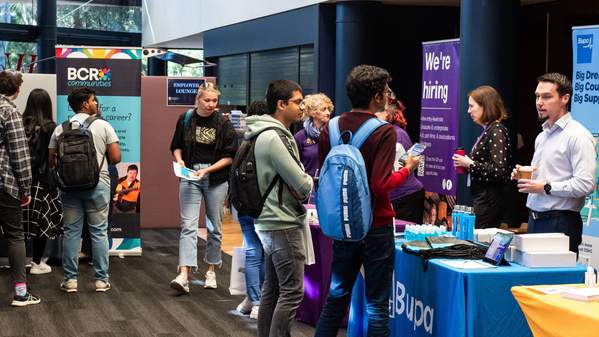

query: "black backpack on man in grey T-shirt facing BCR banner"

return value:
[54, 116, 105, 191]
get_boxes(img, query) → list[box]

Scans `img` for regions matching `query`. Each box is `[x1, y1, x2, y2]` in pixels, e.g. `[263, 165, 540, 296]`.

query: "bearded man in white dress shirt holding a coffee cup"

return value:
[512, 73, 597, 253]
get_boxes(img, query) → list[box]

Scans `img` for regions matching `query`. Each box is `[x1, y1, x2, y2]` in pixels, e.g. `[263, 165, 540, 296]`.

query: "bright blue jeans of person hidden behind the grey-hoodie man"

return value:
[239, 216, 264, 305]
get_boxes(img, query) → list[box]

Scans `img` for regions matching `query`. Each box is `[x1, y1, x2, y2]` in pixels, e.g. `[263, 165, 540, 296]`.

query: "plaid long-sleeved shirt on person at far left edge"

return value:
[0, 95, 31, 200]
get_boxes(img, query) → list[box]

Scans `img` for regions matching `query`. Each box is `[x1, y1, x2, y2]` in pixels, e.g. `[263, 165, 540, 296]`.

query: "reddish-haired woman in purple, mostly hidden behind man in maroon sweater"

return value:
[376, 99, 424, 223]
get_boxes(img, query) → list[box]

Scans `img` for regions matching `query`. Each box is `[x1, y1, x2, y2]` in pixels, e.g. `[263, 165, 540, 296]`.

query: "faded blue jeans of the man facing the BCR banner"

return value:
[61, 181, 110, 282]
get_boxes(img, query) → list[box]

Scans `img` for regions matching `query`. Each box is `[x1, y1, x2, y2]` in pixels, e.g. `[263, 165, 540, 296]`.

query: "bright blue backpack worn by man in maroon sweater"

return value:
[316, 117, 387, 241]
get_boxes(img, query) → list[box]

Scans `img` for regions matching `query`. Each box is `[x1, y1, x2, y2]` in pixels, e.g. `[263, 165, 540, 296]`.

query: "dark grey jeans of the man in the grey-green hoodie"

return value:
[258, 228, 306, 337]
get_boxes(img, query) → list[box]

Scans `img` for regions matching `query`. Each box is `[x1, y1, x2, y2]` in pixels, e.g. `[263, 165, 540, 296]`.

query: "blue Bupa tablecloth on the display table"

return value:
[348, 242, 585, 337]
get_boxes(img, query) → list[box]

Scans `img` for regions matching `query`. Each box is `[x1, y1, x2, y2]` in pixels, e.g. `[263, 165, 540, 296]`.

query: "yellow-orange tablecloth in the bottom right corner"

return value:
[512, 286, 599, 337]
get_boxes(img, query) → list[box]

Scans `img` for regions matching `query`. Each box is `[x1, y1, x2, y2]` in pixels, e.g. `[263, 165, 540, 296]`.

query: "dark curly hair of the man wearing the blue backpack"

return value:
[345, 64, 391, 109]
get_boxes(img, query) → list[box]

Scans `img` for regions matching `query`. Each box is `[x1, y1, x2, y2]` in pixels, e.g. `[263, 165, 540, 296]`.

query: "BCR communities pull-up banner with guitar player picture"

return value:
[56, 46, 141, 255]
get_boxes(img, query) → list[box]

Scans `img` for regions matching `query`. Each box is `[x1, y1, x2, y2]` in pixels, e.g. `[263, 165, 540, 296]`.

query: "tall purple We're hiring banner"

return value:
[419, 39, 460, 225]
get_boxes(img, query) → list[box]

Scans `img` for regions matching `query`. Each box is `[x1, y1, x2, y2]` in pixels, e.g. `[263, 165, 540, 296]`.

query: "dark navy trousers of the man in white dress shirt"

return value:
[528, 211, 582, 254]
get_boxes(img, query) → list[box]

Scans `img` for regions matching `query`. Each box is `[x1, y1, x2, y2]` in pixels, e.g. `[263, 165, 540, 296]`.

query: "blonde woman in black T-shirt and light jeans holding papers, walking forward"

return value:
[170, 82, 237, 294]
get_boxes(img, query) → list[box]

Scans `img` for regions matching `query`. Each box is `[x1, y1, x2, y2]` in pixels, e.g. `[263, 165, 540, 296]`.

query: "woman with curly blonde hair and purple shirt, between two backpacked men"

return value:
[294, 93, 334, 177]
